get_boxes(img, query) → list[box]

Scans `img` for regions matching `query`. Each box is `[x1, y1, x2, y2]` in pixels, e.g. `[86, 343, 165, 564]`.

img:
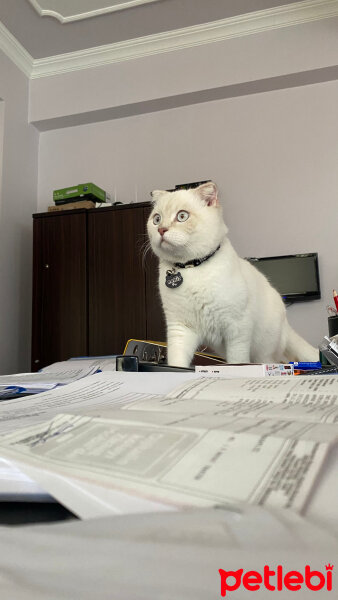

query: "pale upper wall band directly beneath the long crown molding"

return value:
[29, 17, 338, 129]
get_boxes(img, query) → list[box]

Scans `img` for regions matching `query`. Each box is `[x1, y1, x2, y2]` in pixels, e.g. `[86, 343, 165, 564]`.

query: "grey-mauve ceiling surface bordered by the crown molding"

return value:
[0, 0, 304, 59]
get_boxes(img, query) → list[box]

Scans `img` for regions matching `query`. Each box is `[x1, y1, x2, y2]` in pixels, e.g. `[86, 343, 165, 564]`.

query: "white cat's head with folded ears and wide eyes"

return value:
[147, 182, 227, 262]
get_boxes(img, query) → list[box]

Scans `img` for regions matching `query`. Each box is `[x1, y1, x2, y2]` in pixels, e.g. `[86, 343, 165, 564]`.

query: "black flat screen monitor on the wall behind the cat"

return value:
[247, 252, 320, 302]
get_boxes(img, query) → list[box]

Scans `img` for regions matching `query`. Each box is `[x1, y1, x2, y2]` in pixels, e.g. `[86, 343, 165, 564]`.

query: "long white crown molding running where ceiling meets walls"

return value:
[0, 0, 338, 79]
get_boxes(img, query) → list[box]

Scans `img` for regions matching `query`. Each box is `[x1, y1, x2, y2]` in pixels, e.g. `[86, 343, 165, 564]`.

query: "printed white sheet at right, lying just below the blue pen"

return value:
[161, 376, 338, 424]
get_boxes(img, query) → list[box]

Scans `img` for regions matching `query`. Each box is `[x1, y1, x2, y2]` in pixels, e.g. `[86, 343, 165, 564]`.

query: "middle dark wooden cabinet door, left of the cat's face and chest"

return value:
[88, 206, 146, 356]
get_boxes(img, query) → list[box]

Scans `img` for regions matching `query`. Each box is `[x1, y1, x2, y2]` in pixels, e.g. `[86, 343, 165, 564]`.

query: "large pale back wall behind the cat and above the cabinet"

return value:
[38, 82, 338, 344]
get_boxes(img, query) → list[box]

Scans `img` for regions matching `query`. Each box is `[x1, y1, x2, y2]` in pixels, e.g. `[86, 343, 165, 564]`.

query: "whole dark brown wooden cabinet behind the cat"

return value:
[32, 203, 165, 371]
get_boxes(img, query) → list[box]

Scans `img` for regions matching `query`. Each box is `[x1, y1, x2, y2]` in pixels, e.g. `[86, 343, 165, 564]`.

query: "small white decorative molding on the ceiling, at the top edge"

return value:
[29, 0, 162, 23]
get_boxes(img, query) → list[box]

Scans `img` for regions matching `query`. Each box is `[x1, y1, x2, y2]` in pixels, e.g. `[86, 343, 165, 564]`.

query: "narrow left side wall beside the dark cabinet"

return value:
[0, 52, 38, 373]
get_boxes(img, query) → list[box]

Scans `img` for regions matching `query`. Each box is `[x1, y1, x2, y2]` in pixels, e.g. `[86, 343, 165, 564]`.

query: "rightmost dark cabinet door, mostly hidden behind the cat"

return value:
[143, 208, 166, 342]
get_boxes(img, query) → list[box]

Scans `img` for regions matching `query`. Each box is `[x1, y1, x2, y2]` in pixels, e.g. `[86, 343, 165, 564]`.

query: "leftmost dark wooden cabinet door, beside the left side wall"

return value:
[32, 213, 88, 371]
